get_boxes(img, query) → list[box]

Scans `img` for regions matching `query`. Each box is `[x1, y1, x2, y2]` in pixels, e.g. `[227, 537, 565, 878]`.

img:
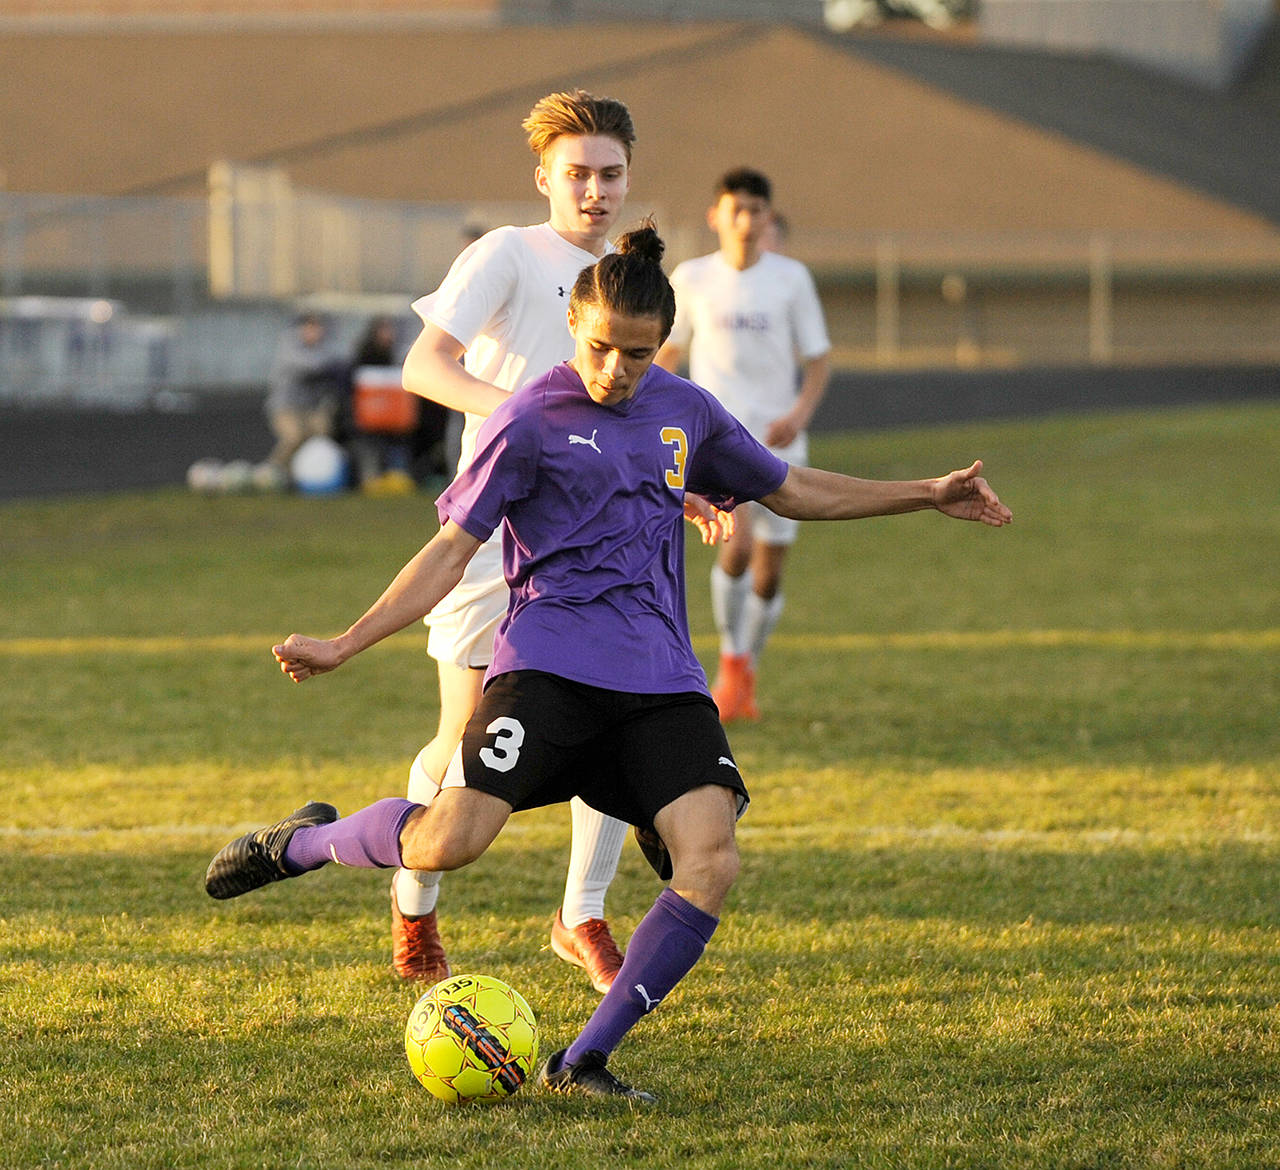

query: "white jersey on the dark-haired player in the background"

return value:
[671, 252, 831, 438]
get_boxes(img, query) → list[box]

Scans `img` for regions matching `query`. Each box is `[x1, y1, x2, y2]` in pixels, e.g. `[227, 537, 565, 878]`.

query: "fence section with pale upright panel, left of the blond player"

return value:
[0, 181, 545, 403]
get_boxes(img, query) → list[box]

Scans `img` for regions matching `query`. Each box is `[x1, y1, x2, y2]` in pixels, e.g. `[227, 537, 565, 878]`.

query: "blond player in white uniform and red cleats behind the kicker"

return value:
[392, 90, 723, 993]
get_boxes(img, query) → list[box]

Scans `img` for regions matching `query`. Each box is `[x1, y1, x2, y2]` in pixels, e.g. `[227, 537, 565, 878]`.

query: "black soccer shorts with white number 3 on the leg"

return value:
[444, 671, 750, 829]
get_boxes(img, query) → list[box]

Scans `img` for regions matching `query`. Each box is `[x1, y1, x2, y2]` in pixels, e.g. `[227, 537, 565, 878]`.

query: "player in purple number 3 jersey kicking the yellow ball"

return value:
[205, 225, 1012, 1101]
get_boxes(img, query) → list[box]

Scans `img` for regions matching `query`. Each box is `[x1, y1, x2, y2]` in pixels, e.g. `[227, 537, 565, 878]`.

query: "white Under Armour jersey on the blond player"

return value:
[413, 224, 596, 467]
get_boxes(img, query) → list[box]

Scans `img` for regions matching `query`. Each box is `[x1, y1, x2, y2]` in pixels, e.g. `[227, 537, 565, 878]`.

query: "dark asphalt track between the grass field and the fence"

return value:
[0, 366, 1280, 499]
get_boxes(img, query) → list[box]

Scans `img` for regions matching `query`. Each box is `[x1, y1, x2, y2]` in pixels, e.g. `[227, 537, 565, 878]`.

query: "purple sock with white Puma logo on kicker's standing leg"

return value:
[564, 888, 719, 1064]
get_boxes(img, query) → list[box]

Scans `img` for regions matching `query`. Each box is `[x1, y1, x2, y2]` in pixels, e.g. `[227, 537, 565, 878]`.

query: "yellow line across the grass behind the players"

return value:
[0, 627, 1280, 658]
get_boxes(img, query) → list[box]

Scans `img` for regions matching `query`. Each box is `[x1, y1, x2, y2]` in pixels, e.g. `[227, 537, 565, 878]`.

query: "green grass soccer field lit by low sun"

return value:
[0, 403, 1280, 1170]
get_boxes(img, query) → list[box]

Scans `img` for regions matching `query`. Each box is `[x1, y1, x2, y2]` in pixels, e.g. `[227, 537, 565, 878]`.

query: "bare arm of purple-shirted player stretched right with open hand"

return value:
[760, 461, 1014, 527]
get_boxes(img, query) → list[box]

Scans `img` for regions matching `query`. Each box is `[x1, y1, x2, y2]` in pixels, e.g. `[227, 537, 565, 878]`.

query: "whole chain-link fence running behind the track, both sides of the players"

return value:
[0, 181, 1280, 405]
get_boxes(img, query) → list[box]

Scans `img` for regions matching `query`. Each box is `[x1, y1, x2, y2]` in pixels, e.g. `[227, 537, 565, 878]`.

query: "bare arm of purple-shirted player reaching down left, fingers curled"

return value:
[271, 521, 481, 682]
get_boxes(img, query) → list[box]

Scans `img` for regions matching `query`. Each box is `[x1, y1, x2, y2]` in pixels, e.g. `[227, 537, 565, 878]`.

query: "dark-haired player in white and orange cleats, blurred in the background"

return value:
[658, 168, 831, 723]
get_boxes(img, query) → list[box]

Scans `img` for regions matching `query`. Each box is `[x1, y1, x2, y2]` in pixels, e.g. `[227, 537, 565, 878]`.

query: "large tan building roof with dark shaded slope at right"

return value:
[0, 23, 1280, 259]
